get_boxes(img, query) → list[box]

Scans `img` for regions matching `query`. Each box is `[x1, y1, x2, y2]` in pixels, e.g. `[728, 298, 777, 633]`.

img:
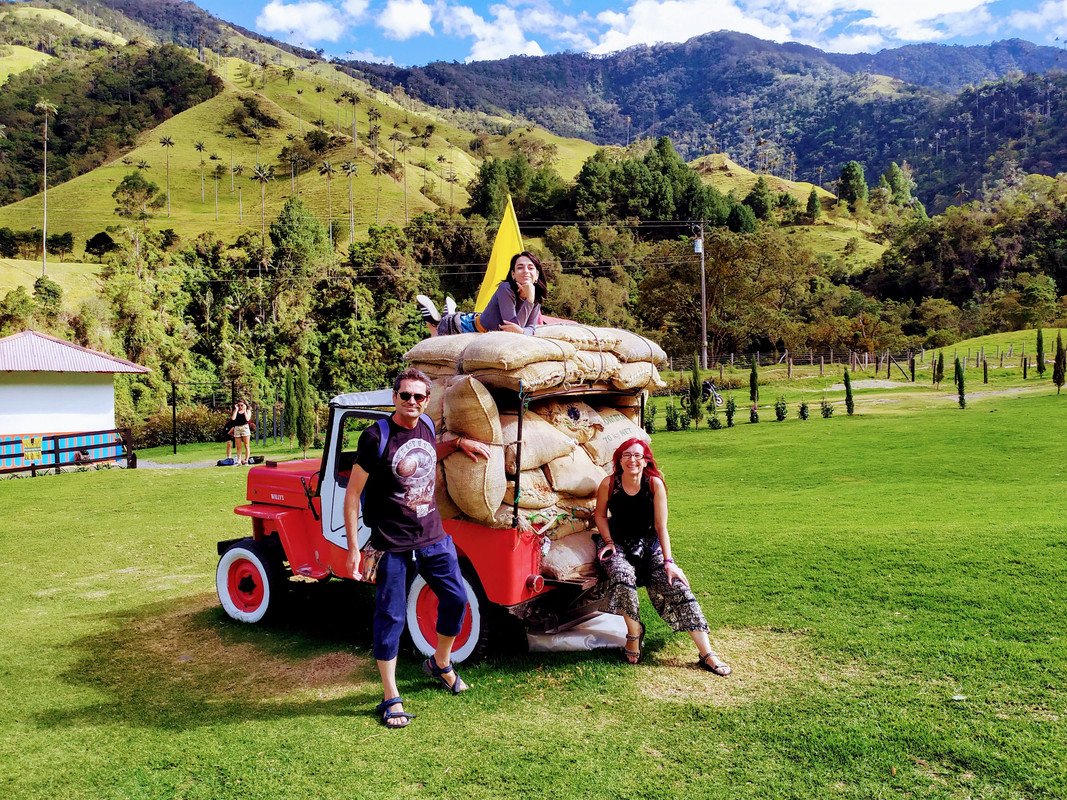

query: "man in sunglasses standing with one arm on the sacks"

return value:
[345, 367, 490, 727]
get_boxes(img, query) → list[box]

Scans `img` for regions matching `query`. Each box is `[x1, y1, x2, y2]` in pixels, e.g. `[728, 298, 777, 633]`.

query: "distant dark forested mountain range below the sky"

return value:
[359, 32, 1067, 210]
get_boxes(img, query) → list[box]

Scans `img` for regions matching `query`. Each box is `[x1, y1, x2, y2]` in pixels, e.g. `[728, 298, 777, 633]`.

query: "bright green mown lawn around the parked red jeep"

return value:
[0, 386, 1067, 799]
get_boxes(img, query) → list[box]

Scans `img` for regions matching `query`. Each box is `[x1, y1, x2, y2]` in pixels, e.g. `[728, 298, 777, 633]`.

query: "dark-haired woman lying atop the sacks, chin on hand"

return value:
[415, 252, 547, 336]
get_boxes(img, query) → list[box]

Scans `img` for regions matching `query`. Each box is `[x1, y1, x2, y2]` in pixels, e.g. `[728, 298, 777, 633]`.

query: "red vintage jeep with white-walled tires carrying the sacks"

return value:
[216, 385, 643, 661]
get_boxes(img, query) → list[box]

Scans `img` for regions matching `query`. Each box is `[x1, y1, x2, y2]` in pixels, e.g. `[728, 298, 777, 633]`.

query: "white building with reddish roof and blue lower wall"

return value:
[0, 331, 152, 468]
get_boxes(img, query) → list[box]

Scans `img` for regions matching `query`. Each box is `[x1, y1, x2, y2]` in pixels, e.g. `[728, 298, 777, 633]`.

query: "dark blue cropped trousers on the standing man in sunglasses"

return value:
[373, 535, 466, 661]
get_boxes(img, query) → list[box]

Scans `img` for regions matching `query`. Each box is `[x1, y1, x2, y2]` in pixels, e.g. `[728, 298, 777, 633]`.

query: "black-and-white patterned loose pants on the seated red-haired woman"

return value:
[601, 539, 707, 630]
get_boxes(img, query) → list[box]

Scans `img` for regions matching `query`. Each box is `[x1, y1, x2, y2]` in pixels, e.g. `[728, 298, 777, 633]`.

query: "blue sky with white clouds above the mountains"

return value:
[187, 0, 1067, 66]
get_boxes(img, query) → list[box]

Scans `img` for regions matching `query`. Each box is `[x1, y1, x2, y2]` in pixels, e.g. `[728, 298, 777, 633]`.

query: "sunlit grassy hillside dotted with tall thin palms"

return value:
[0, 50, 593, 258]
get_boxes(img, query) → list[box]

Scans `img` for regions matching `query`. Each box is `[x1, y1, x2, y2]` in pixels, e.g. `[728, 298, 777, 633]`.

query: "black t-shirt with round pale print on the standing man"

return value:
[355, 417, 445, 553]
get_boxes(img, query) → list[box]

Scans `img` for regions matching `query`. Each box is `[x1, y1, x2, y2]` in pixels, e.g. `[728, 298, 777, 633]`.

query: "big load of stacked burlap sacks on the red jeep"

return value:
[405, 325, 665, 580]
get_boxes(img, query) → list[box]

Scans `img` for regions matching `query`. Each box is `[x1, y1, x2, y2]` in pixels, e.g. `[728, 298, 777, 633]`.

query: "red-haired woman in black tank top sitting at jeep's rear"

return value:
[594, 438, 731, 677]
